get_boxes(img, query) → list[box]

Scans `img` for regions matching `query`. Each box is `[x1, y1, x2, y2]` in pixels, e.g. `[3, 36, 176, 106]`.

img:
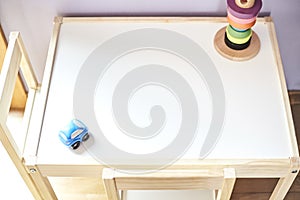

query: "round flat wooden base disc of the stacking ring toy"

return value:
[214, 27, 260, 61]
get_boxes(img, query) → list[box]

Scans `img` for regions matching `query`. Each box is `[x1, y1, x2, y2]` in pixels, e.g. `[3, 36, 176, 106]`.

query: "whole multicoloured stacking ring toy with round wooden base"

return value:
[214, 0, 262, 61]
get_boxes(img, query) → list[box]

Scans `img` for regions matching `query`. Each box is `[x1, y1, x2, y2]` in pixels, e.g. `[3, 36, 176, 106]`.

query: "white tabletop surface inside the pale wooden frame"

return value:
[38, 18, 293, 164]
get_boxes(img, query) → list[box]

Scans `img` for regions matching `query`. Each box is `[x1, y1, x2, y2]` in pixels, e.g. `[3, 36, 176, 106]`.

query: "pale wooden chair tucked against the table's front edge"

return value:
[102, 168, 236, 200]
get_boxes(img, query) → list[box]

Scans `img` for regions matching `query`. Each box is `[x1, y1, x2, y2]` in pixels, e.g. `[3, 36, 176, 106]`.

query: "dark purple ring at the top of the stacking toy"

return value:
[227, 0, 262, 19]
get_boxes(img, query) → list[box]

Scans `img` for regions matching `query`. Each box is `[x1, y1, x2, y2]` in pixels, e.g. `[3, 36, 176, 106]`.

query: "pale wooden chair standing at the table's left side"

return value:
[0, 32, 49, 199]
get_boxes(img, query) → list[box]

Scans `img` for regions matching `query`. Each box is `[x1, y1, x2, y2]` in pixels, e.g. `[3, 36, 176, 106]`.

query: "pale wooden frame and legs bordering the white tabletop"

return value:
[1, 17, 300, 199]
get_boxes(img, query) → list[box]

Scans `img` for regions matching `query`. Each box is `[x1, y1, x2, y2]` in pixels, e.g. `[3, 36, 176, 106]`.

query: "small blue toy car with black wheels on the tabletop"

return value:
[58, 119, 89, 149]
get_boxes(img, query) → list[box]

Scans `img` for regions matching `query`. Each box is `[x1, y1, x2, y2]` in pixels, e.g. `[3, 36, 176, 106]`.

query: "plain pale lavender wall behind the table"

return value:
[0, 0, 300, 89]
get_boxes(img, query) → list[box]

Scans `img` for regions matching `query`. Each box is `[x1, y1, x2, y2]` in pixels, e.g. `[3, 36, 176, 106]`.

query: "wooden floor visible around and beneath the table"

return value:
[0, 92, 300, 200]
